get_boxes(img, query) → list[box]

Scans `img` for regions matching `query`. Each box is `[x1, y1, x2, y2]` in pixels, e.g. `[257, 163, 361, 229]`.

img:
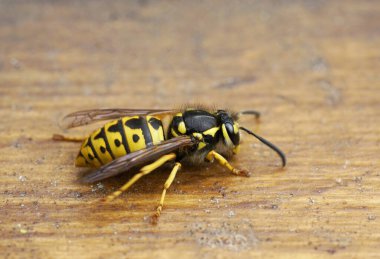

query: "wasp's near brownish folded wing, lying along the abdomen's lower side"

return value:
[82, 136, 195, 183]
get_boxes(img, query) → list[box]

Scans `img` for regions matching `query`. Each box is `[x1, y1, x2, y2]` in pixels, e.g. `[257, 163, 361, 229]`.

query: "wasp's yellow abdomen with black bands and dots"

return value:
[75, 116, 164, 167]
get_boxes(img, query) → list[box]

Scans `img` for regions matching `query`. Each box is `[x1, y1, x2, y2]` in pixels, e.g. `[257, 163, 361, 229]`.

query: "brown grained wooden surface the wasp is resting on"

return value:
[0, 0, 380, 258]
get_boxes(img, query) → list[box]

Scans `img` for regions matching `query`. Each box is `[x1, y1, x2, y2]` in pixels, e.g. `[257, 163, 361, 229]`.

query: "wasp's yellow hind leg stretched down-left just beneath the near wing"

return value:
[105, 153, 176, 202]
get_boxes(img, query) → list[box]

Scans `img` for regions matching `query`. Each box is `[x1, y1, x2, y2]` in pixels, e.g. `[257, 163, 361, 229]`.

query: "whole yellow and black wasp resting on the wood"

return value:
[53, 107, 286, 222]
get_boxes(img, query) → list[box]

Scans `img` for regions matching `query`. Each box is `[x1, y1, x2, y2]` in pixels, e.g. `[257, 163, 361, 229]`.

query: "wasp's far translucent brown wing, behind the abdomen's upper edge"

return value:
[60, 109, 175, 129]
